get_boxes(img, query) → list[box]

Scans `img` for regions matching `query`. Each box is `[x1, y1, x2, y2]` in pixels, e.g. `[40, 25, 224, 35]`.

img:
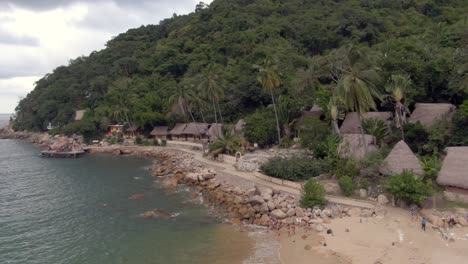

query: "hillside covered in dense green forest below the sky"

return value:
[14, 0, 468, 138]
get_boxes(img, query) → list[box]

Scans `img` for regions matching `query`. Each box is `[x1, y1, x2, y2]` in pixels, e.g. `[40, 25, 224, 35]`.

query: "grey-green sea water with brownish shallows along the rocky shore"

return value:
[0, 140, 255, 264]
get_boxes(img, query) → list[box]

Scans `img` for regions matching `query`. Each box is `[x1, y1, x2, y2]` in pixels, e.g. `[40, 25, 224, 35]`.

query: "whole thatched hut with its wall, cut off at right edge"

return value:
[437, 147, 468, 203]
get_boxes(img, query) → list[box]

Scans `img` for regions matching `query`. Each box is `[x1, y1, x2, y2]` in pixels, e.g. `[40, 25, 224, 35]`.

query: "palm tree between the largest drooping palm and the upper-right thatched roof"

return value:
[385, 74, 411, 140]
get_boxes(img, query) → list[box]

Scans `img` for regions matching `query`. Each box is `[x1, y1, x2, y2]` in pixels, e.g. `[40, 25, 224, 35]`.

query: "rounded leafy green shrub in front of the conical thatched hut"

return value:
[386, 170, 433, 204]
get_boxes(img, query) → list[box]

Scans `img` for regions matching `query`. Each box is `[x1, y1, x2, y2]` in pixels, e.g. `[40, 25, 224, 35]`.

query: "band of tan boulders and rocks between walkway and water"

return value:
[153, 151, 386, 232]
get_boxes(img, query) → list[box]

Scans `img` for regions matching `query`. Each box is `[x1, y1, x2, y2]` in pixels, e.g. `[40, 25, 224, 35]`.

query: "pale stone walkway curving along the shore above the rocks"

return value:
[170, 147, 376, 208]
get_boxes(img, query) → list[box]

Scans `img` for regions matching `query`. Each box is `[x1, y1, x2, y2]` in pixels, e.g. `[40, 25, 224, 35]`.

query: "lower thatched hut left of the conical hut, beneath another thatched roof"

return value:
[338, 134, 377, 160]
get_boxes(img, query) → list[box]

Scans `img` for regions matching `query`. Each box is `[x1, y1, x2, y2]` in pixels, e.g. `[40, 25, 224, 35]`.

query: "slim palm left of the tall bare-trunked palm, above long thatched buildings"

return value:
[198, 64, 224, 123]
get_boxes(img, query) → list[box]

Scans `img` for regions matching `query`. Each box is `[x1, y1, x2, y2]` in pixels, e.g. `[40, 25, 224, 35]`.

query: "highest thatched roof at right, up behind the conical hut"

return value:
[408, 103, 456, 127]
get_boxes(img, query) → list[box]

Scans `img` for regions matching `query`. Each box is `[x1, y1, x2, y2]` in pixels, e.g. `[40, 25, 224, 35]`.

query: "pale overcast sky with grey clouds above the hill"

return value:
[0, 0, 211, 113]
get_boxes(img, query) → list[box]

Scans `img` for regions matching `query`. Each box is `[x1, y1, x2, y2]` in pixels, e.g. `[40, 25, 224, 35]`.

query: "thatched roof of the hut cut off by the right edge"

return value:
[437, 147, 468, 189]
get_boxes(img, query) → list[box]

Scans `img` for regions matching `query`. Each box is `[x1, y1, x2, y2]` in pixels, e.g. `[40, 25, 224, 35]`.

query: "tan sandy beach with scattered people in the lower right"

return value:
[281, 208, 468, 264]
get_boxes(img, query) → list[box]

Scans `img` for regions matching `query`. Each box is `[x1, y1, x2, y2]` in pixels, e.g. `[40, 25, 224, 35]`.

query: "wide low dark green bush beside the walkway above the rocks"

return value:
[260, 156, 328, 181]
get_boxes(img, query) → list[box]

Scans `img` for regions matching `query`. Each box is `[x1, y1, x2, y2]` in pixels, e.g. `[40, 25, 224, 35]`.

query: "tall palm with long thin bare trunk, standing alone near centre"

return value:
[254, 59, 281, 144]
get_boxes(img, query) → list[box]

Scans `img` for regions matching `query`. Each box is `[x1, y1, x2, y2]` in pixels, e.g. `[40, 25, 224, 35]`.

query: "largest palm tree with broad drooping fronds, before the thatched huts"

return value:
[335, 46, 381, 152]
